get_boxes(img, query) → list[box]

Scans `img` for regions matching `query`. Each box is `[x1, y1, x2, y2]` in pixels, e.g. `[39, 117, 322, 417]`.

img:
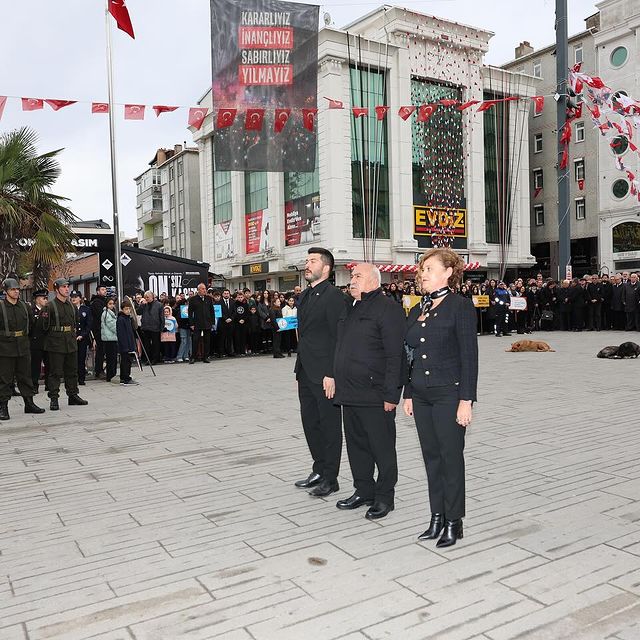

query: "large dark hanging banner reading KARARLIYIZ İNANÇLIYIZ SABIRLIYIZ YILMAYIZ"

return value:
[211, 0, 319, 172]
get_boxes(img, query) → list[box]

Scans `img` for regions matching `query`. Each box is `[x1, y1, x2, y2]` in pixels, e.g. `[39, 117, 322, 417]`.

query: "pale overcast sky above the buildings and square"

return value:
[0, 0, 596, 235]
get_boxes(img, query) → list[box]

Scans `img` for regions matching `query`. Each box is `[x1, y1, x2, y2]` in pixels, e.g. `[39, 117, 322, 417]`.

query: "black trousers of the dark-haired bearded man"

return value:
[298, 369, 342, 482]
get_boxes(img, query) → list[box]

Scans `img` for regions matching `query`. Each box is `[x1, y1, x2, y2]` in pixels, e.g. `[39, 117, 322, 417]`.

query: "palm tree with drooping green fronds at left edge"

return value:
[0, 127, 76, 287]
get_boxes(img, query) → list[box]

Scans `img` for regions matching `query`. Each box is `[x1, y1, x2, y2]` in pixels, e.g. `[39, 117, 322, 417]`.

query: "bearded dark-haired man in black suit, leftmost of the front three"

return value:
[295, 247, 345, 497]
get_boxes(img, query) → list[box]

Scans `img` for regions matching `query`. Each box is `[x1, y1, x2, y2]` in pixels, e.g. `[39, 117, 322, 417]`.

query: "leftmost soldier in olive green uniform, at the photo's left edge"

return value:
[0, 278, 44, 420]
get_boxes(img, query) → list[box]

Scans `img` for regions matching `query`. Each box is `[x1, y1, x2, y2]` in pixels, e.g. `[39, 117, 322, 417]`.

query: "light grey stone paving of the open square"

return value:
[0, 332, 640, 640]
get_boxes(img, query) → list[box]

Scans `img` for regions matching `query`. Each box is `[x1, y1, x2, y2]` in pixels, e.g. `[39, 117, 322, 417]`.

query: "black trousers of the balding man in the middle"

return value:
[342, 406, 398, 504]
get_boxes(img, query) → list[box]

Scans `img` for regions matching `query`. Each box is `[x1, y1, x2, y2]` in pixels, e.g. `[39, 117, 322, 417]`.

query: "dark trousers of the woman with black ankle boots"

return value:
[412, 385, 466, 520]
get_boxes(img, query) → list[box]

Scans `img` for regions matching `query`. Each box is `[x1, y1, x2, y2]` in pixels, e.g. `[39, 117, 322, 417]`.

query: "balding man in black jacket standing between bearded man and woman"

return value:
[334, 263, 406, 520]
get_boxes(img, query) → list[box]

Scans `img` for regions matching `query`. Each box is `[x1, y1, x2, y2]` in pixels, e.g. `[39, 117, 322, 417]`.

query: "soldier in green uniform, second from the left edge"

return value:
[38, 278, 89, 411]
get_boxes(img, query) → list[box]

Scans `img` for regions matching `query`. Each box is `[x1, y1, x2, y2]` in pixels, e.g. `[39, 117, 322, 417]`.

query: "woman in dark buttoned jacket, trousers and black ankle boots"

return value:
[404, 249, 478, 547]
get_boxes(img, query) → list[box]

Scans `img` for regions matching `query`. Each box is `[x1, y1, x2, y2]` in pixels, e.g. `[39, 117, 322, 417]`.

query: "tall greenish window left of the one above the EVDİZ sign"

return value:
[349, 67, 390, 238]
